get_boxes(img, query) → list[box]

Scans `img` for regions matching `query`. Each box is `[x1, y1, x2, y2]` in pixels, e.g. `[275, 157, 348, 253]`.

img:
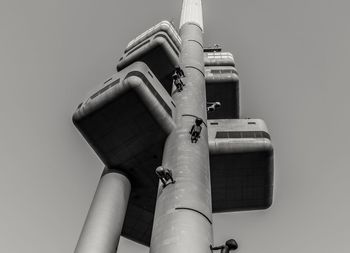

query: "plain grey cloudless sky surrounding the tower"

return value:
[0, 0, 350, 253]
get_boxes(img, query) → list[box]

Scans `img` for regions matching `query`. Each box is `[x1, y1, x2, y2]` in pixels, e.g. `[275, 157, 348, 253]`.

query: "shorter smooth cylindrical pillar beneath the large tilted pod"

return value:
[74, 169, 131, 253]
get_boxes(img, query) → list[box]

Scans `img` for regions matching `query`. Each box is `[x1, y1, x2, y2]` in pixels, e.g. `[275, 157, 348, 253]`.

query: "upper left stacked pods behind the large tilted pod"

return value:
[117, 21, 181, 94]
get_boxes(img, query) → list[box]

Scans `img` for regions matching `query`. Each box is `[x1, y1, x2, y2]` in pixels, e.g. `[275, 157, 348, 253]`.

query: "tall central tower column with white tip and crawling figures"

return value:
[150, 0, 213, 253]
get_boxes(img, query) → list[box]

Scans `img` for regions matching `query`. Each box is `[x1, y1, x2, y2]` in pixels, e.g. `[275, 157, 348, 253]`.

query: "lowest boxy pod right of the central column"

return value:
[208, 119, 273, 212]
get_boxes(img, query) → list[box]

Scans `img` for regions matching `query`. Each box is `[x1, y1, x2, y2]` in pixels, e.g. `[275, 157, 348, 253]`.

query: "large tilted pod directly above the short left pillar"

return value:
[73, 62, 175, 169]
